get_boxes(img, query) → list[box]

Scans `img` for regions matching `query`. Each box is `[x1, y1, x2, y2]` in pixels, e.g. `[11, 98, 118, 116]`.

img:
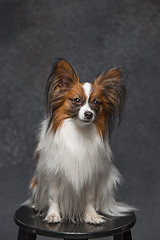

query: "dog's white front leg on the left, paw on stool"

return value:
[45, 181, 61, 223]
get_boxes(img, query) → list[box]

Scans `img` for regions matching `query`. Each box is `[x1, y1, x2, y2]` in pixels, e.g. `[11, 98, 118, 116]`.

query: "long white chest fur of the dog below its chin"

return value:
[37, 119, 111, 191]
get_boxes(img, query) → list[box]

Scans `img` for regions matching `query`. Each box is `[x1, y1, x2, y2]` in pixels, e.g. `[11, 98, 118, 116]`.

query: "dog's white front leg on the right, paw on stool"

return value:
[84, 185, 105, 224]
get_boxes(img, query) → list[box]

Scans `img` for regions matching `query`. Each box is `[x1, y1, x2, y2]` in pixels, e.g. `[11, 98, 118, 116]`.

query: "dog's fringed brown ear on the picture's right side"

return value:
[95, 68, 127, 135]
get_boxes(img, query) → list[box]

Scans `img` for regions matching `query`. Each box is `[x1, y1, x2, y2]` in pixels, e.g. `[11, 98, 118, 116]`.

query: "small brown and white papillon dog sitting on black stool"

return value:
[30, 59, 132, 224]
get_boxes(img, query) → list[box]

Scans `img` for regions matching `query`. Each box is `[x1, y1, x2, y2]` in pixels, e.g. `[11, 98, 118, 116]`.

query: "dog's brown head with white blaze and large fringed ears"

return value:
[46, 59, 126, 136]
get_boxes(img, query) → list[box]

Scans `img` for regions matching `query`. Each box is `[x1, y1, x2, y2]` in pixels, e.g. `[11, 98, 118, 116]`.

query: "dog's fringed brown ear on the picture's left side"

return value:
[46, 59, 79, 112]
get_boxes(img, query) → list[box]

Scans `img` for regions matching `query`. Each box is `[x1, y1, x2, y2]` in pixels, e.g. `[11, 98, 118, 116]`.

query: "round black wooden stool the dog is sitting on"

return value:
[14, 206, 136, 240]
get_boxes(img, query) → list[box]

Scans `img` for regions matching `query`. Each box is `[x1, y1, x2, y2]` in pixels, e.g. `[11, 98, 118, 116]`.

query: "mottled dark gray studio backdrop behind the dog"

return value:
[0, 0, 160, 240]
